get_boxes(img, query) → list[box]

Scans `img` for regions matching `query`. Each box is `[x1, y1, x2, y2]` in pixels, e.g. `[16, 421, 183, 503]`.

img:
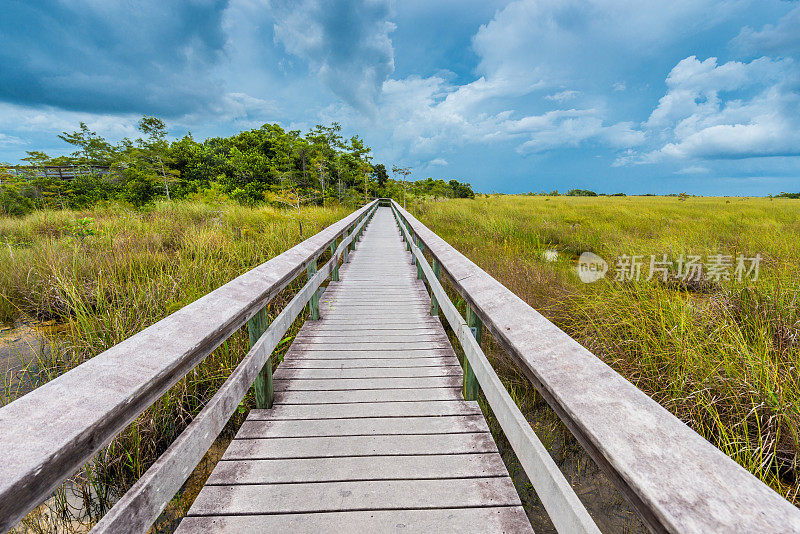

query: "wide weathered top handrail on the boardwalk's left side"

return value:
[0, 201, 376, 530]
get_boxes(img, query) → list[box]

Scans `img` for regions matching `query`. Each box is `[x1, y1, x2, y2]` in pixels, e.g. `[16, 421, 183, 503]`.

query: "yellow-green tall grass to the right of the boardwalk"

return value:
[416, 196, 800, 504]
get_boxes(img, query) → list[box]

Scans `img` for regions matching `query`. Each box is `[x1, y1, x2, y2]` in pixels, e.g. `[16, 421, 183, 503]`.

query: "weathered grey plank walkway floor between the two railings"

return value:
[178, 208, 532, 533]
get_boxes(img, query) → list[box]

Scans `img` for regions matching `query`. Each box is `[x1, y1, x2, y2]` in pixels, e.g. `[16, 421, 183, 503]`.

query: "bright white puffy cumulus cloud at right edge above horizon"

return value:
[623, 56, 800, 163]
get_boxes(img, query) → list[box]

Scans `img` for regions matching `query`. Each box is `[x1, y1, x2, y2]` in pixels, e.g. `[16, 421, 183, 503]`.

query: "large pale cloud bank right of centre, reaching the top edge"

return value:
[350, 0, 736, 164]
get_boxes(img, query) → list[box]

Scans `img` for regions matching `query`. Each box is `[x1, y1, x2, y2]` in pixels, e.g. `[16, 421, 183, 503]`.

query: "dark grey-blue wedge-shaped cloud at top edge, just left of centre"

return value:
[271, 0, 395, 113]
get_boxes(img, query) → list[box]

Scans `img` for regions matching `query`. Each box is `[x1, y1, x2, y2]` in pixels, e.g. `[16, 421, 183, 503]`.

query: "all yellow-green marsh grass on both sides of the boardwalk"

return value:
[0, 196, 800, 531]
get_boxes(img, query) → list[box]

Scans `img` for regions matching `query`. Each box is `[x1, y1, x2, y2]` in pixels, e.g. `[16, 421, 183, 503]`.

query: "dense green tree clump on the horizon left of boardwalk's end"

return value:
[0, 117, 474, 215]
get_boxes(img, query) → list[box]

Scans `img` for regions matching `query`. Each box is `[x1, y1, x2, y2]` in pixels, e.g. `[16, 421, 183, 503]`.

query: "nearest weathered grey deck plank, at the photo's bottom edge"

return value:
[177, 506, 530, 534]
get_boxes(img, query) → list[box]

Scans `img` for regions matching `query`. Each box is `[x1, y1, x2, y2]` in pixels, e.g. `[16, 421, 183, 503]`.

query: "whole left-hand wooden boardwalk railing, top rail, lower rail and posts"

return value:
[0, 201, 377, 532]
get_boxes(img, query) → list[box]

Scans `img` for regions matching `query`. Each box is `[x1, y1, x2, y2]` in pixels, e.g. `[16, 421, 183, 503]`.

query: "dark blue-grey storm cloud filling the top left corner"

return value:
[0, 0, 228, 116]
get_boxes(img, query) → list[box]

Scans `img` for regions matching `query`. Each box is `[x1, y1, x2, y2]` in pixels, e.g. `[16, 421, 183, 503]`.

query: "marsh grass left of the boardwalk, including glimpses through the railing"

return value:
[0, 203, 351, 532]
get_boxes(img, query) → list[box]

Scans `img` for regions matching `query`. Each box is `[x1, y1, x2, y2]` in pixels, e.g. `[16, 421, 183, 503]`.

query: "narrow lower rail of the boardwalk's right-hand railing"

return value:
[392, 207, 600, 534]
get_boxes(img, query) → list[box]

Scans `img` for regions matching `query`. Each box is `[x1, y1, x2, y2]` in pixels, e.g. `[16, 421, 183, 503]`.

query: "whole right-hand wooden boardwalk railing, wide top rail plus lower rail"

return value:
[392, 201, 800, 533]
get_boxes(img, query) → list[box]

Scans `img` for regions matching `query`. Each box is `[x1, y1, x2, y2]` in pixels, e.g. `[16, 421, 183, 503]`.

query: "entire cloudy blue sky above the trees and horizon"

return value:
[0, 0, 800, 195]
